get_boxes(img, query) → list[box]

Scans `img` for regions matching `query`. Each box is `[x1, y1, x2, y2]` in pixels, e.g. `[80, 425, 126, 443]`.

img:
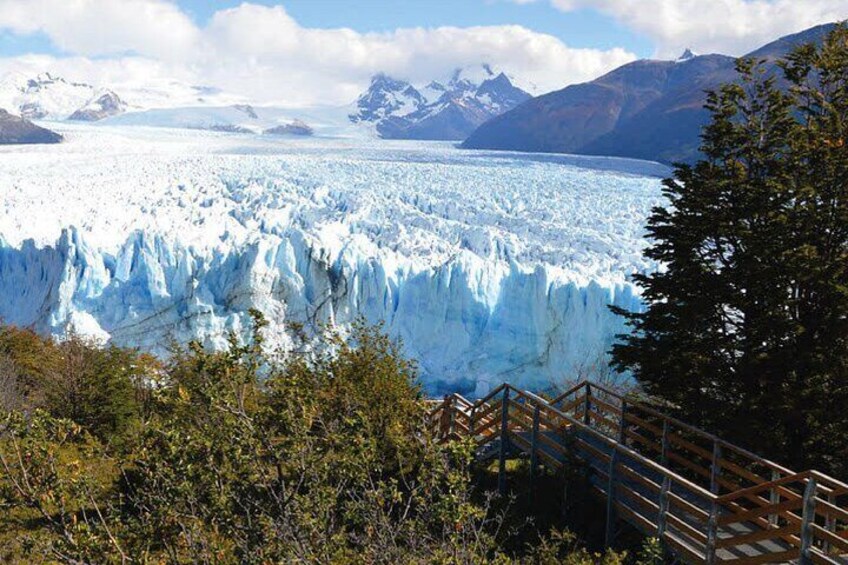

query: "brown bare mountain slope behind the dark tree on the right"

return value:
[463, 24, 834, 162]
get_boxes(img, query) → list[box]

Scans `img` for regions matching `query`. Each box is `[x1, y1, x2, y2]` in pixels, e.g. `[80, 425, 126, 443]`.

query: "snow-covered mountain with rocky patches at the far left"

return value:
[0, 73, 126, 121]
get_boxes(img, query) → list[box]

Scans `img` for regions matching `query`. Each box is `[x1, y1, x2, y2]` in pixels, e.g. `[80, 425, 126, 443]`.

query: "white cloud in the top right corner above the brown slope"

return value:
[536, 0, 848, 57]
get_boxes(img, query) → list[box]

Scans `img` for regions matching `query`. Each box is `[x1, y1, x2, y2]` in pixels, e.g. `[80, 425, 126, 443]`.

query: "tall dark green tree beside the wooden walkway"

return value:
[612, 26, 848, 474]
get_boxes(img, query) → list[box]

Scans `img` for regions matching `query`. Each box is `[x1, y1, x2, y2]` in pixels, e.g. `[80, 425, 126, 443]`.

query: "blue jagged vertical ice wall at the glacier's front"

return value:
[0, 228, 640, 393]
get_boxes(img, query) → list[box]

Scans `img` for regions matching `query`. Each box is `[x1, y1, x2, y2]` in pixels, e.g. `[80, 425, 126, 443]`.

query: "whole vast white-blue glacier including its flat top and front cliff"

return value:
[0, 124, 668, 394]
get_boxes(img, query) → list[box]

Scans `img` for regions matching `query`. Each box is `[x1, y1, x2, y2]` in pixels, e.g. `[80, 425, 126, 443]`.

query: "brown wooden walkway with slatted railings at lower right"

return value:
[430, 382, 848, 565]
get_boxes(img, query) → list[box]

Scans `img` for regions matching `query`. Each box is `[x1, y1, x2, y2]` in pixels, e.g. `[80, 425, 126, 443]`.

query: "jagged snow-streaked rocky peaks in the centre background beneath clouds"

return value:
[350, 65, 530, 140]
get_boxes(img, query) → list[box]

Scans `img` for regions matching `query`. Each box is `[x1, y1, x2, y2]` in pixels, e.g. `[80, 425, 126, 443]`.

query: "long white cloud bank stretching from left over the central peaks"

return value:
[0, 0, 635, 104]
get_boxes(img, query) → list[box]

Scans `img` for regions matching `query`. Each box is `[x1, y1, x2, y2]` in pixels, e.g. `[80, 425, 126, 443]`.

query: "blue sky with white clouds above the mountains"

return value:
[0, 0, 848, 106]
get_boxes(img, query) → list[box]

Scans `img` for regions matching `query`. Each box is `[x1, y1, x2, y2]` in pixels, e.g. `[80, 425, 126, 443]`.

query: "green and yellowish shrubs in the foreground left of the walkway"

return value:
[0, 313, 648, 564]
